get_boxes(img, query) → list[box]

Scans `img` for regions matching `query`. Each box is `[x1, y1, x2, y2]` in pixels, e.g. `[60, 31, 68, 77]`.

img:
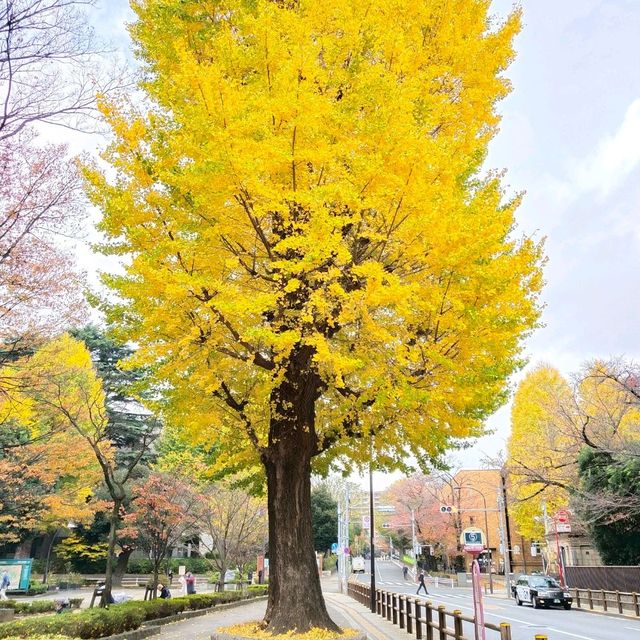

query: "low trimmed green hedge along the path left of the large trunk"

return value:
[0, 585, 266, 639]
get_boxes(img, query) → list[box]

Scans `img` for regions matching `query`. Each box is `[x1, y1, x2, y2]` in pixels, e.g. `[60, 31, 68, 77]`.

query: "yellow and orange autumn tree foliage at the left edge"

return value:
[0, 339, 104, 542]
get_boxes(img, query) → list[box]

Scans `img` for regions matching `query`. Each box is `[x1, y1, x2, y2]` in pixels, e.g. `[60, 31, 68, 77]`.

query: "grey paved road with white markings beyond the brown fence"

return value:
[350, 561, 640, 640]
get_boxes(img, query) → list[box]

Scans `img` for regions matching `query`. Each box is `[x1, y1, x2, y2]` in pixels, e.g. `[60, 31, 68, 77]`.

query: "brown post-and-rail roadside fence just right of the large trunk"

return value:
[348, 582, 548, 640]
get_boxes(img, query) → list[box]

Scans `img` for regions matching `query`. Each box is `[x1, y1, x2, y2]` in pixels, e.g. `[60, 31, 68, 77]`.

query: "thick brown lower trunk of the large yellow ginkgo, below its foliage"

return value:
[263, 434, 339, 633]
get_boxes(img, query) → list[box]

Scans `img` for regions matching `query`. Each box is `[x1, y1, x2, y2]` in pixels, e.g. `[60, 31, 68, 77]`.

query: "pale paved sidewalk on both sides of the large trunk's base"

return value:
[156, 576, 407, 640]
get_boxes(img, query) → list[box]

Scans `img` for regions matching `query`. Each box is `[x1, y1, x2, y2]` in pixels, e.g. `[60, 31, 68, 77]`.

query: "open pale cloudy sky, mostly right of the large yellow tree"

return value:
[65, 0, 640, 485]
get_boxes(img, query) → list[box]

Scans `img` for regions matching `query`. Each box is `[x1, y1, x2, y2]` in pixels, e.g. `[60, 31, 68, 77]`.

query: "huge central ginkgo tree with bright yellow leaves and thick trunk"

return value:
[85, 0, 541, 633]
